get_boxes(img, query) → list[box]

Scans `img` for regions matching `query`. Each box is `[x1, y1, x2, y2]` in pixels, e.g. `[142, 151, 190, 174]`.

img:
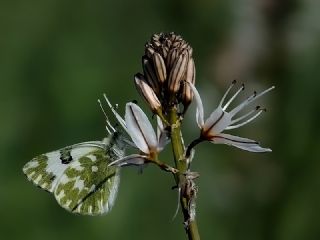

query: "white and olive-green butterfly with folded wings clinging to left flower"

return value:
[23, 95, 125, 216]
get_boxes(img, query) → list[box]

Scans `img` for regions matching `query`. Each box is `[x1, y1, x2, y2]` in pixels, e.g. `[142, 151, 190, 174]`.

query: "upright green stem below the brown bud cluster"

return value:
[169, 107, 200, 240]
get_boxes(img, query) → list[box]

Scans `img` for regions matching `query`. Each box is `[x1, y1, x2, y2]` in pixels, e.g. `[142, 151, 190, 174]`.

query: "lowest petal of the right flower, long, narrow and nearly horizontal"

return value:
[211, 133, 272, 152]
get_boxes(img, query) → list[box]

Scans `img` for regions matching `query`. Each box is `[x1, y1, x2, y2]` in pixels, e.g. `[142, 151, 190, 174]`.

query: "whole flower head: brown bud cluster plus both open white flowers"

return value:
[106, 33, 274, 172]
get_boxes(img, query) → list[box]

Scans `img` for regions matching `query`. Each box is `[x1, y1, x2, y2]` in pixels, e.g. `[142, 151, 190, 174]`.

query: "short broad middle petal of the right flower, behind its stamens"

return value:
[203, 106, 231, 136]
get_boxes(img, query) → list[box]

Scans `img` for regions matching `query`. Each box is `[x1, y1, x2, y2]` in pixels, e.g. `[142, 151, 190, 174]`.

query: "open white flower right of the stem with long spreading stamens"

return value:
[188, 81, 274, 152]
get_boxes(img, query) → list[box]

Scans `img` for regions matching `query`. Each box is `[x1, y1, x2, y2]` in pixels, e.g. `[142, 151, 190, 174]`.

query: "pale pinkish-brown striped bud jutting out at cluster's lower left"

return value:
[134, 73, 161, 113]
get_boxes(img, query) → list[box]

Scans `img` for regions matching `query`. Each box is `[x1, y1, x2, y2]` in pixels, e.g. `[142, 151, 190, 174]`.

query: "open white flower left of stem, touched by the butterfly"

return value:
[105, 96, 167, 167]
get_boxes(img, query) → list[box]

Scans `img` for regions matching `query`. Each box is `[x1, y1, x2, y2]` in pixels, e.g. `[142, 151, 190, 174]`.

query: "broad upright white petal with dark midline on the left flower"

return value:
[125, 103, 158, 153]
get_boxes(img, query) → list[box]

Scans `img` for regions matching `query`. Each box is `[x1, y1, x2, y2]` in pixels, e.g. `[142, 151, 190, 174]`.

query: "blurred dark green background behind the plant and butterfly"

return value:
[0, 0, 320, 240]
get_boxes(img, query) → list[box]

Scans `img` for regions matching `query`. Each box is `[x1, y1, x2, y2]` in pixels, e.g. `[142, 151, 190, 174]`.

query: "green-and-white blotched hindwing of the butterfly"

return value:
[54, 149, 119, 215]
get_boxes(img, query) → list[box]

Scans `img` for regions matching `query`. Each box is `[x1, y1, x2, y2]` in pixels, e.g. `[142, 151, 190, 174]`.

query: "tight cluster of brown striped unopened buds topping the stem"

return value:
[134, 33, 195, 116]
